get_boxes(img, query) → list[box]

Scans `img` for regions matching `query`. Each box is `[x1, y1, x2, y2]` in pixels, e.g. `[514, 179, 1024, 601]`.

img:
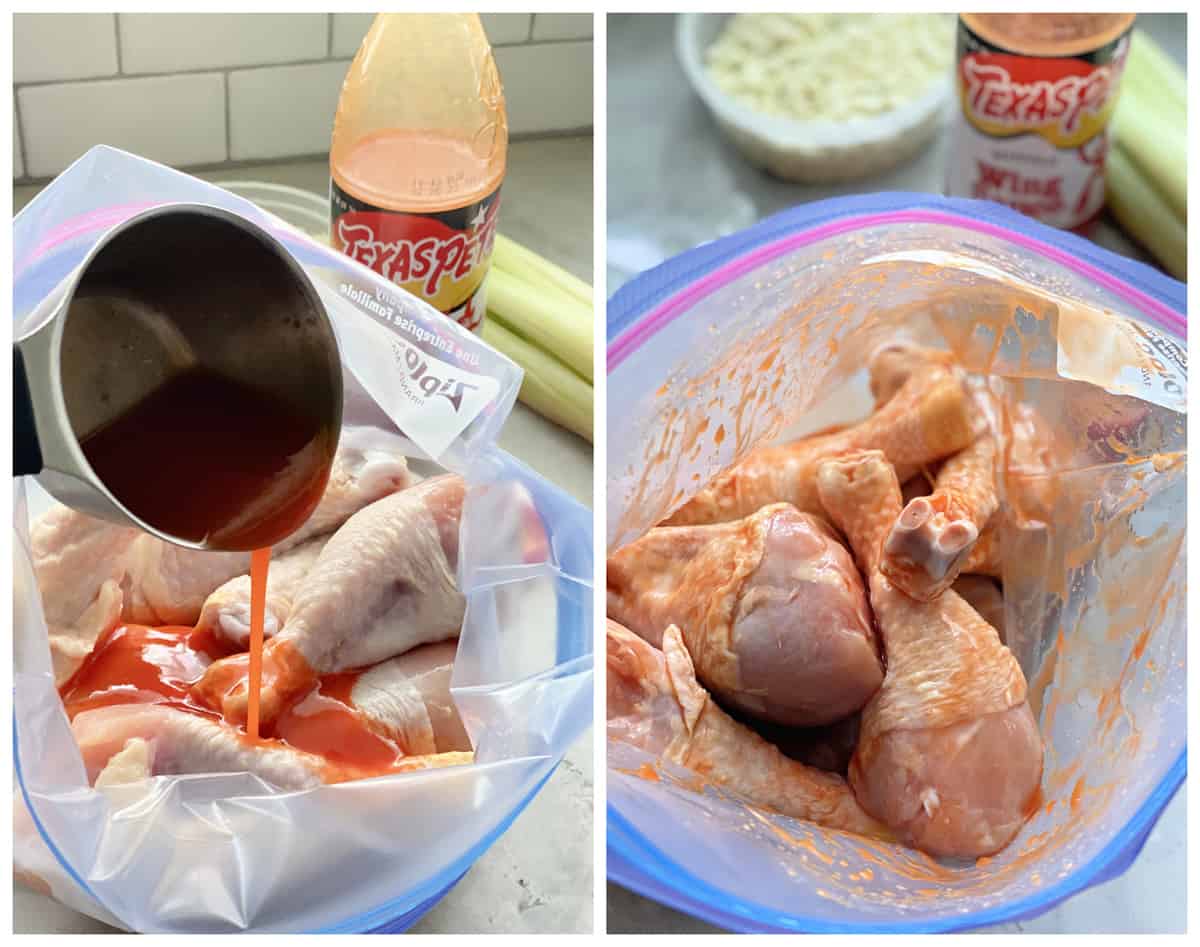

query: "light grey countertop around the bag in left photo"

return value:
[13, 131, 593, 934]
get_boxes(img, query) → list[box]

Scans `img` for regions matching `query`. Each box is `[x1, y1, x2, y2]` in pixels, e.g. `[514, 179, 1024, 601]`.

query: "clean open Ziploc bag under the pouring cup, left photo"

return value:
[13, 146, 592, 933]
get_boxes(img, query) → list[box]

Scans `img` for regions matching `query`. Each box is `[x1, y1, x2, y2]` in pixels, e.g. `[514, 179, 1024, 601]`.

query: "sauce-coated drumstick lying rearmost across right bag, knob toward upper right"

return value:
[664, 368, 973, 526]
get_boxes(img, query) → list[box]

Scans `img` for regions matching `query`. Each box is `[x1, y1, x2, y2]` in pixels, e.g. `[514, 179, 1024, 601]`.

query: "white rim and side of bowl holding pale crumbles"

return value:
[676, 13, 953, 184]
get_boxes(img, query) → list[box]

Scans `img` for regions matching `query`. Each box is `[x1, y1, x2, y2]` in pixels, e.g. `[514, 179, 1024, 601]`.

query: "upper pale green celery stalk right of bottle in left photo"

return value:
[487, 264, 593, 383]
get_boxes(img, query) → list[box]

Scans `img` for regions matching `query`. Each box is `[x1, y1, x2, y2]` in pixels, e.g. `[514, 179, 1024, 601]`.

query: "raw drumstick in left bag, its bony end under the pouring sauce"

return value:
[193, 474, 466, 726]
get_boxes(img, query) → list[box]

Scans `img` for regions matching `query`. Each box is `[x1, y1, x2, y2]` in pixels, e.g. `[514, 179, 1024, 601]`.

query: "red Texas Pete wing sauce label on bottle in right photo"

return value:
[947, 19, 1129, 228]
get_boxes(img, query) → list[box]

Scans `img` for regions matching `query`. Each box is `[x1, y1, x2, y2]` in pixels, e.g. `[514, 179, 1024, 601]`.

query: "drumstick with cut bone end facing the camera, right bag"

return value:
[880, 433, 1000, 601]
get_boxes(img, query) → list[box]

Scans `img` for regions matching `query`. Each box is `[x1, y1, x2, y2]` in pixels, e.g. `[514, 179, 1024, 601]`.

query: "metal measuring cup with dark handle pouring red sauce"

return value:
[13, 204, 342, 550]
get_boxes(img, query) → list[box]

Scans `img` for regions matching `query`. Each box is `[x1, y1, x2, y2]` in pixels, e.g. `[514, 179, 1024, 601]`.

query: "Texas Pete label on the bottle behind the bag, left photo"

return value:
[329, 179, 500, 331]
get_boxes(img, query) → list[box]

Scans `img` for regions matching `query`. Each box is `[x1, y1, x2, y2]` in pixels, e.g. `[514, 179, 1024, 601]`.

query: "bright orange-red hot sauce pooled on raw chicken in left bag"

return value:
[59, 624, 404, 781]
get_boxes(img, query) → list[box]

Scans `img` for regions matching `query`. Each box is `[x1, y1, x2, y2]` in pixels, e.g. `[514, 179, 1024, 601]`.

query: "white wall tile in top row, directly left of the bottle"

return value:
[116, 13, 329, 73]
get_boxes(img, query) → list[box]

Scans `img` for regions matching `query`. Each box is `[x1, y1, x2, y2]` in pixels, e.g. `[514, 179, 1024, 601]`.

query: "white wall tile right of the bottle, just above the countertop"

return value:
[496, 42, 592, 134]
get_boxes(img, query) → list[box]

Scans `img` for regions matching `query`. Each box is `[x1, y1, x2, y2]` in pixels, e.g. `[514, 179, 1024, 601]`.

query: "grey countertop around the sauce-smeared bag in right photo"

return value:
[606, 14, 1187, 933]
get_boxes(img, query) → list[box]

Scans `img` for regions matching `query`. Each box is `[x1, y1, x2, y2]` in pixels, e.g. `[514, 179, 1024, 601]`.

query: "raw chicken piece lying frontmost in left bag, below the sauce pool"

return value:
[71, 703, 472, 790]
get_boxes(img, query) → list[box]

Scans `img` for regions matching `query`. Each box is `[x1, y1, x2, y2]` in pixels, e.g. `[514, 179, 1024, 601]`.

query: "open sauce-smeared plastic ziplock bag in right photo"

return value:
[607, 194, 1187, 931]
